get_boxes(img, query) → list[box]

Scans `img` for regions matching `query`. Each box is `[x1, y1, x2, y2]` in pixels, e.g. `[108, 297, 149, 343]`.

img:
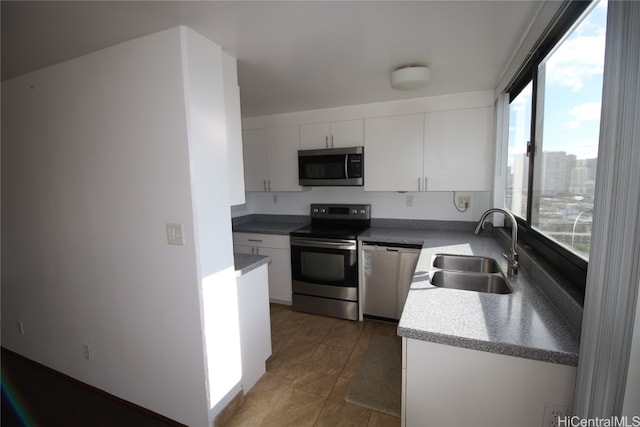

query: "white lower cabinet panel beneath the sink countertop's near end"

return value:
[402, 338, 576, 427]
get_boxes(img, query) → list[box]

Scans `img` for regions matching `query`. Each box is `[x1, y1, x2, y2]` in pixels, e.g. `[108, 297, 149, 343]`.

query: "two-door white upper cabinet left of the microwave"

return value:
[243, 126, 302, 191]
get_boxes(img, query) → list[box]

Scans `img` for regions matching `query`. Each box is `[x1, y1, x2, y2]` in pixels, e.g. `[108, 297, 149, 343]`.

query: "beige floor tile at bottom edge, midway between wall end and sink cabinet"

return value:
[261, 388, 325, 427]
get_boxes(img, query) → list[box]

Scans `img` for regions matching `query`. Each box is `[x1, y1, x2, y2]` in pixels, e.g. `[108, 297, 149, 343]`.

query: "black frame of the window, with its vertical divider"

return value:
[505, 0, 593, 296]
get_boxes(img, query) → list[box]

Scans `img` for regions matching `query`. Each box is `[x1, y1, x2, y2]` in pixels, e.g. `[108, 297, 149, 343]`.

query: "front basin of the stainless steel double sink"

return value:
[431, 270, 512, 294]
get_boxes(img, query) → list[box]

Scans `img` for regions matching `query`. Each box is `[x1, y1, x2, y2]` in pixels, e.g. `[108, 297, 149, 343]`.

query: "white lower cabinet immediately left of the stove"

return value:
[233, 232, 291, 305]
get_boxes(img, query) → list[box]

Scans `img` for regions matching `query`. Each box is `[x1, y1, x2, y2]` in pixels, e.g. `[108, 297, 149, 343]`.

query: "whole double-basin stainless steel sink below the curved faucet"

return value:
[430, 254, 512, 294]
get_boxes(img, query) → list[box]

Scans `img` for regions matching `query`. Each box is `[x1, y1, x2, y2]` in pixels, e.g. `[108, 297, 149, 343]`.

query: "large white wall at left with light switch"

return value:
[2, 29, 238, 426]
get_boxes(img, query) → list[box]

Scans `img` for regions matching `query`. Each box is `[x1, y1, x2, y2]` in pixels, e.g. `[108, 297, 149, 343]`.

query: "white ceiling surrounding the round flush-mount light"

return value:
[1, 0, 543, 117]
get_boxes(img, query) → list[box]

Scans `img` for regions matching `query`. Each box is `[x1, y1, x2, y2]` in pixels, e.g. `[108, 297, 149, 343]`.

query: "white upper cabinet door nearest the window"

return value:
[424, 107, 494, 191]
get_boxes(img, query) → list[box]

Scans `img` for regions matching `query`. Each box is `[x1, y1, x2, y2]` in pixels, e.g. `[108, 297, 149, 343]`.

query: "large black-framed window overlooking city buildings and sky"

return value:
[505, 1, 607, 290]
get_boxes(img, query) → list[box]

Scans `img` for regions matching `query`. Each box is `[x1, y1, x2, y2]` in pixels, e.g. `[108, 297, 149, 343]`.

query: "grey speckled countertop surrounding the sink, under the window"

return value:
[359, 227, 580, 366]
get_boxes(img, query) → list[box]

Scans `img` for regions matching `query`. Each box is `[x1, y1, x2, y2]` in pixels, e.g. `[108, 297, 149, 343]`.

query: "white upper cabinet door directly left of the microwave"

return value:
[265, 126, 302, 191]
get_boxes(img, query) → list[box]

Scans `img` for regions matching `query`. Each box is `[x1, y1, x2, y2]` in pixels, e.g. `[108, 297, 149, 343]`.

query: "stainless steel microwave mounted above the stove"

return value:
[298, 147, 364, 186]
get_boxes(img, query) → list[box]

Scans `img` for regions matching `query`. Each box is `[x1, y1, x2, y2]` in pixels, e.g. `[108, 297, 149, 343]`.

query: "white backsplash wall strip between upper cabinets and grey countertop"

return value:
[232, 187, 491, 221]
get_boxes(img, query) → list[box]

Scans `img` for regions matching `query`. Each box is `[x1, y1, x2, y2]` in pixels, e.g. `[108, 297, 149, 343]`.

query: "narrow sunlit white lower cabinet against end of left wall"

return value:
[236, 264, 271, 394]
